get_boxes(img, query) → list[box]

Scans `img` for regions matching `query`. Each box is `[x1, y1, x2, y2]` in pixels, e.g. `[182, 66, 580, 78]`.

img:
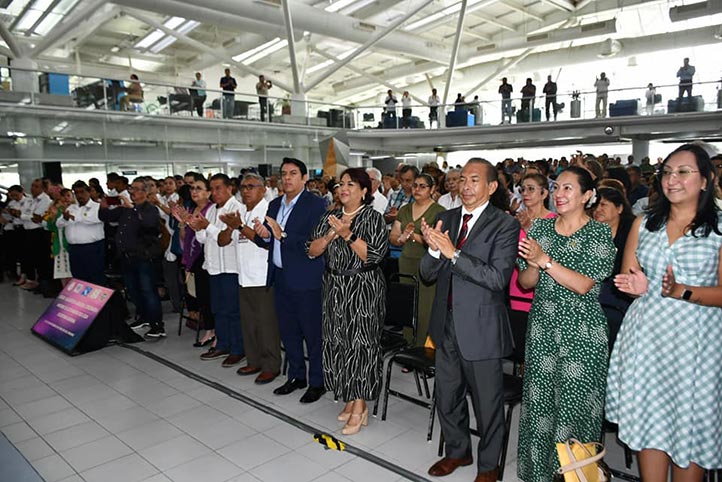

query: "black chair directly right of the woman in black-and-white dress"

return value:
[373, 273, 421, 416]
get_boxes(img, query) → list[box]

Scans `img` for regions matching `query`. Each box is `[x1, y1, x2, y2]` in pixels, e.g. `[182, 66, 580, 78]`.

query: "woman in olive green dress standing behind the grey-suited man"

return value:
[389, 173, 446, 346]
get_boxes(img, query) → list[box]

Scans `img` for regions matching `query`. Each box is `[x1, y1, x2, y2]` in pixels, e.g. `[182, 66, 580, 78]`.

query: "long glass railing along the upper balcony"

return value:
[0, 69, 722, 129]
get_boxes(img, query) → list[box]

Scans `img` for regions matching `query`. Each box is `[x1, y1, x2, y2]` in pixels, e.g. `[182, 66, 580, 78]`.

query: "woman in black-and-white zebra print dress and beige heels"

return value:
[307, 168, 387, 435]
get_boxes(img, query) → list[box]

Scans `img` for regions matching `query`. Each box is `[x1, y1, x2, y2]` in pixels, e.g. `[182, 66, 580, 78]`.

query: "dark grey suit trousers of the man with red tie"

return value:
[435, 312, 505, 472]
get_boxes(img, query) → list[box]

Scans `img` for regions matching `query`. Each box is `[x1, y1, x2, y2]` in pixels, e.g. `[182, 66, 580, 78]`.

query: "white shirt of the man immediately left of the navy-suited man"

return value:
[231, 199, 268, 288]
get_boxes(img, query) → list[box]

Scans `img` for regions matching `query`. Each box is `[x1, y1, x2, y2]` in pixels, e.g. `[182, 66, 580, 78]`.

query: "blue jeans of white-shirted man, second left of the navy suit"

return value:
[211, 273, 245, 356]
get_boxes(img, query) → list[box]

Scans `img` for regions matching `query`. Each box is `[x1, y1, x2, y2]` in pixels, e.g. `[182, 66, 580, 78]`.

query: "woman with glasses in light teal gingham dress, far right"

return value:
[606, 144, 722, 482]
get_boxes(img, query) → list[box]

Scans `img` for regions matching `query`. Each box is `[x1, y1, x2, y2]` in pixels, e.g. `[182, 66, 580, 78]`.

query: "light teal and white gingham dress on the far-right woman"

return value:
[607, 214, 722, 469]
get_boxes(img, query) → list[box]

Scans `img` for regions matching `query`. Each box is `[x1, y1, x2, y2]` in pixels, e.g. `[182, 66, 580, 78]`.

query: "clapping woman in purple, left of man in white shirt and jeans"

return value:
[171, 175, 216, 349]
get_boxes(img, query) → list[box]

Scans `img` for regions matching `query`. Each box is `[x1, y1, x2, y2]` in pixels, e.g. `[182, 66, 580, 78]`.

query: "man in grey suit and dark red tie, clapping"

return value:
[421, 158, 519, 482]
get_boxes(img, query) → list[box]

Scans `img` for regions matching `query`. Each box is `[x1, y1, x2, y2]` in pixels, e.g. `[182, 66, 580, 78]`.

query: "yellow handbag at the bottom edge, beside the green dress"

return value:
[554, 438, 611, 482]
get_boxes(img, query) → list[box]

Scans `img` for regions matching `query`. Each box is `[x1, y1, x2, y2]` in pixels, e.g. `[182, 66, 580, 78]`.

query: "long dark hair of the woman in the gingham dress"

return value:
[644, 144, 722, 238]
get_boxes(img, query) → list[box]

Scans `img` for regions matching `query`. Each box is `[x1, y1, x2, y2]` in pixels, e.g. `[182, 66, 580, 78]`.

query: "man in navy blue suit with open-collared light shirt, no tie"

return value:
[253, 157, 326, 403]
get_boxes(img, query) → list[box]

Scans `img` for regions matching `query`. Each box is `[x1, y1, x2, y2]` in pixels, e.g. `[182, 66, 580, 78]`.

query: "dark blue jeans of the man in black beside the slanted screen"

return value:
[121, 257, 163, 329]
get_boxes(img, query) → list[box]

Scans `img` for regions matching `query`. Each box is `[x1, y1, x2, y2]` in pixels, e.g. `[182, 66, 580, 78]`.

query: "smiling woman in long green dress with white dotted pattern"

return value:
[517, 166, 616, 482]
